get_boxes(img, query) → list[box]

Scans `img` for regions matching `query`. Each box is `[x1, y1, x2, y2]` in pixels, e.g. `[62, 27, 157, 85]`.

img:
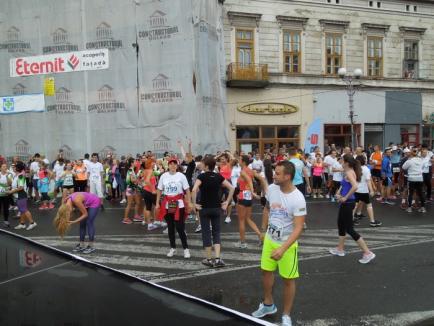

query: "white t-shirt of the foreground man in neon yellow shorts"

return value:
[265, 184, 307, 243]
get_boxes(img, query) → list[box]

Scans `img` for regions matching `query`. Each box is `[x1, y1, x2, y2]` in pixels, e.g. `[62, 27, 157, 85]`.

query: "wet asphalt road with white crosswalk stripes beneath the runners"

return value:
[1, 200, 434, 326]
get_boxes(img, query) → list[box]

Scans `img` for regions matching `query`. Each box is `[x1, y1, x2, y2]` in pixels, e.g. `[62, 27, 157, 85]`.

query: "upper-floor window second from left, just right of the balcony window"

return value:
[283, 31, 301, 73]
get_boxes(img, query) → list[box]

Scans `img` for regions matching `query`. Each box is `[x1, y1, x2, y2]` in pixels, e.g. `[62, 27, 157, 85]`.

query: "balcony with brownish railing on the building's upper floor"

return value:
[226, 62, 269, 88]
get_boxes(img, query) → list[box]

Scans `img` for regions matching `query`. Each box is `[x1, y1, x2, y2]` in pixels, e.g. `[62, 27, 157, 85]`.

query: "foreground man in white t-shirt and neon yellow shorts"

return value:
[252, 161, 307, 326]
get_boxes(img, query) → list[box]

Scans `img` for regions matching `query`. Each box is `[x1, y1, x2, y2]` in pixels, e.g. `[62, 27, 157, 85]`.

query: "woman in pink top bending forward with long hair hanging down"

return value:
[54, 192, 101, 254]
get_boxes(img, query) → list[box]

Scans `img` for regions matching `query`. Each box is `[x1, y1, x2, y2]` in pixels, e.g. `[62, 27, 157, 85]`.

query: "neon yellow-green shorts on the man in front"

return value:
[261, 235, 299, 279]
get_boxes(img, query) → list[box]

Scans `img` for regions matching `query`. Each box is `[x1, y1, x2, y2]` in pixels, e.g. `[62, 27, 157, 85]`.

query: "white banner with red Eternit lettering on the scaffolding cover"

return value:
[10, 49, 109, 77]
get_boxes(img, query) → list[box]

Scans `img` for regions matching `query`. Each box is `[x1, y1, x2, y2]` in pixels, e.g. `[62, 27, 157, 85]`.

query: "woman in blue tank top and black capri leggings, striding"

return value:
[329, 154, 375, 264]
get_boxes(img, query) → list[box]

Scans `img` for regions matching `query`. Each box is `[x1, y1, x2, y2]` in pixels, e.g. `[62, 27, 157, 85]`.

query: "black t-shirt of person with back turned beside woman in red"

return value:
[197, 172, 225, 208]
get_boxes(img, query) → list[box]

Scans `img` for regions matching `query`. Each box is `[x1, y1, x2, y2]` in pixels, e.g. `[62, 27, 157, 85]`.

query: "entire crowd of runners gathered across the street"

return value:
[0, 141, 434, 325]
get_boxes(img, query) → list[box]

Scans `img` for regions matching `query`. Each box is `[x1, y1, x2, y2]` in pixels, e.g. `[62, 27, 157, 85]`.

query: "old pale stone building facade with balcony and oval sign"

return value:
[223, 0, 434, 153]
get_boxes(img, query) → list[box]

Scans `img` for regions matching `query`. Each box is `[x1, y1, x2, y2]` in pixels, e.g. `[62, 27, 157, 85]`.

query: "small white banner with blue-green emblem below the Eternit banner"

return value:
[0, 94, 45, 114]
